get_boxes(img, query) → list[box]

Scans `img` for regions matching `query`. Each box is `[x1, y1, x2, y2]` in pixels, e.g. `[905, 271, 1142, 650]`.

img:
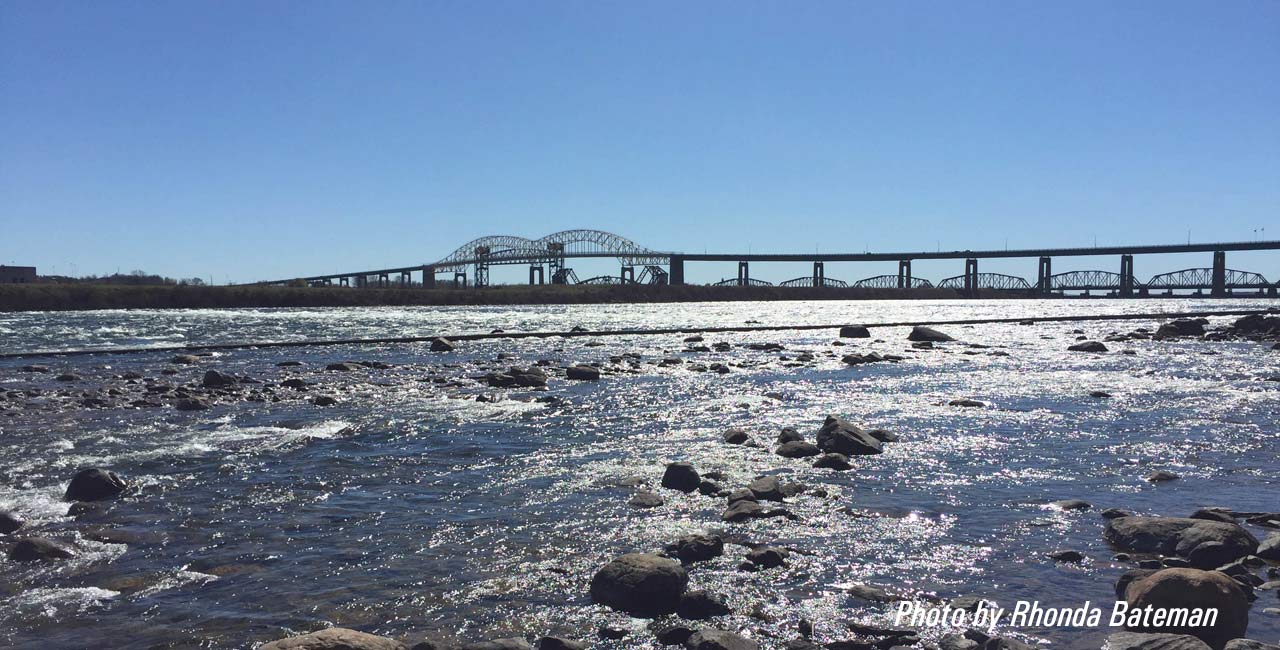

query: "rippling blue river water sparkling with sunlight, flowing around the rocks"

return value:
[0, 299, 1280, 647]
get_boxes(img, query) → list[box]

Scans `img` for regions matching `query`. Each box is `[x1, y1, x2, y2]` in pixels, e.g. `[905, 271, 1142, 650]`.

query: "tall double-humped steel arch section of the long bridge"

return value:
[431, 229, 669, 271]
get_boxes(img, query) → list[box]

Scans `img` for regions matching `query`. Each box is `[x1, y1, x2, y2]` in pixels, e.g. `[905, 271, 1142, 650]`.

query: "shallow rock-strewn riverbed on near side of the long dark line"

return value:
[0, 303, 1280, 650]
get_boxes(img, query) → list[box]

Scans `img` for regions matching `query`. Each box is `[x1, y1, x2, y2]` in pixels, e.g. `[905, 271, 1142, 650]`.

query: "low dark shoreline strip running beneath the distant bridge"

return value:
[0, 284, 1259, 312]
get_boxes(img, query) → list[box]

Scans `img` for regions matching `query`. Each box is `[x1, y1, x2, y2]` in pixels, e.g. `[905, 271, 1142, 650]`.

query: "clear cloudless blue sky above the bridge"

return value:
[0, 0, 1280, 283]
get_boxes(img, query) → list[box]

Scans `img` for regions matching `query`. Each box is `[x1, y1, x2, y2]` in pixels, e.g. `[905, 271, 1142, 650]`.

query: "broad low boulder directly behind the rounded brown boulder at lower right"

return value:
[1102, 517, 1258, 568]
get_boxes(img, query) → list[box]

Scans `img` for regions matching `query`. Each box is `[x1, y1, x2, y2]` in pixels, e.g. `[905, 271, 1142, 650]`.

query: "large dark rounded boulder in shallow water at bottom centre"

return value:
[591, 553, 689, 618]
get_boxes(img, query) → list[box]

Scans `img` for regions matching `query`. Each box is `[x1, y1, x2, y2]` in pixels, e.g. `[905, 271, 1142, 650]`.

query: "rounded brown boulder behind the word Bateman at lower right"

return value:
[1125, 568, 1249, 649]
